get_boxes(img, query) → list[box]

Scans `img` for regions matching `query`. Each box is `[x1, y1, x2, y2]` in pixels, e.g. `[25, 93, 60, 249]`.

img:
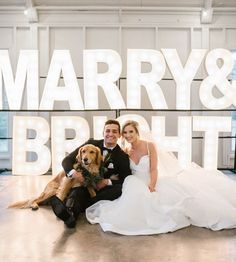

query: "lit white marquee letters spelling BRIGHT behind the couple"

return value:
[12, 114, 231, 175]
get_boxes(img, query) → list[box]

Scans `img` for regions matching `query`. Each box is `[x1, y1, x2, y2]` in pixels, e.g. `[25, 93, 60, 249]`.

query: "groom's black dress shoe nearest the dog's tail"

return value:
[50, 196, 76, 228]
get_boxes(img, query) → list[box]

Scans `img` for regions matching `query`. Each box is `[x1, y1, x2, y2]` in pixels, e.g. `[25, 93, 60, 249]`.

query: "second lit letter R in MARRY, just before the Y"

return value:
[127, 49, 168, 109]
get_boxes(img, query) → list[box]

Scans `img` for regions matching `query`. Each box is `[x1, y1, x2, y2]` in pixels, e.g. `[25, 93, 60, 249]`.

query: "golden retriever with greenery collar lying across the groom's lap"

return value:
[9, 144, 102, 210]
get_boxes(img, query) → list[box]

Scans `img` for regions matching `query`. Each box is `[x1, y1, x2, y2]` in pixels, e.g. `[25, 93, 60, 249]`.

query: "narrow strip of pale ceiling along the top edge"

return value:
[0, 0, 236, 8]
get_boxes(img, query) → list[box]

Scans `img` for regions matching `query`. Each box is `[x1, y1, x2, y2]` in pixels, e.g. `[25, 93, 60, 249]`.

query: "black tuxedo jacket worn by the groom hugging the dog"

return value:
[62, 139, 131, 184]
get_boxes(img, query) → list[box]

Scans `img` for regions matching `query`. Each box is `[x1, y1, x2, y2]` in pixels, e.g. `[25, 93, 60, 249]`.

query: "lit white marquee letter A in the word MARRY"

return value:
[40, 50, 84, 110]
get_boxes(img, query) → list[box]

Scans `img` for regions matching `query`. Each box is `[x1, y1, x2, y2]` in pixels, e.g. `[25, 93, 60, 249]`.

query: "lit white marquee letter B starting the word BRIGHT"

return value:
[12, 116, 51, 175]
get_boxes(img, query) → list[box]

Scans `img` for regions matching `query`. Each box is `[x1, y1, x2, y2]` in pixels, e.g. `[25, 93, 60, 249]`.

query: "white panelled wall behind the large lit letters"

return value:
[0, 7, 236, 167]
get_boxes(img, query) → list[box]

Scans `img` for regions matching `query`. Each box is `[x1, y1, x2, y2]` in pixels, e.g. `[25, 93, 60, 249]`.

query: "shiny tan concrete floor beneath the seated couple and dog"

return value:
[0, 175, 236, 262]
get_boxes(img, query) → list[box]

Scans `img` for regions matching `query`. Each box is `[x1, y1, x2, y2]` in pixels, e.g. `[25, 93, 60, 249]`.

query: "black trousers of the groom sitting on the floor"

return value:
[66, 184, 122, 218]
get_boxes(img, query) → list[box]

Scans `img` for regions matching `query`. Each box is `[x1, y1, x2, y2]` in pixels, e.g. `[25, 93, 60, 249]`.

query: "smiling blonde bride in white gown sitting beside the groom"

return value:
[86, 121, 236, 235]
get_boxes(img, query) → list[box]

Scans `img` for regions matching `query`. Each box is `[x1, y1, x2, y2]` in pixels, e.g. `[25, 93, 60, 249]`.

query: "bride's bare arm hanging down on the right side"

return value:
[148, 143, 158, 192]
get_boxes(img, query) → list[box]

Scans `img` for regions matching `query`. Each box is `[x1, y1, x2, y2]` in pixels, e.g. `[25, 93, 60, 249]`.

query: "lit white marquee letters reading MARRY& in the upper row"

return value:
[0, 49, 236, 110]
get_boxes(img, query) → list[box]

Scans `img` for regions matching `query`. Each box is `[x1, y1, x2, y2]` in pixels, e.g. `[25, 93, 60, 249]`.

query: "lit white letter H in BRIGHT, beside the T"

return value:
[152, 116, 192, 168]
